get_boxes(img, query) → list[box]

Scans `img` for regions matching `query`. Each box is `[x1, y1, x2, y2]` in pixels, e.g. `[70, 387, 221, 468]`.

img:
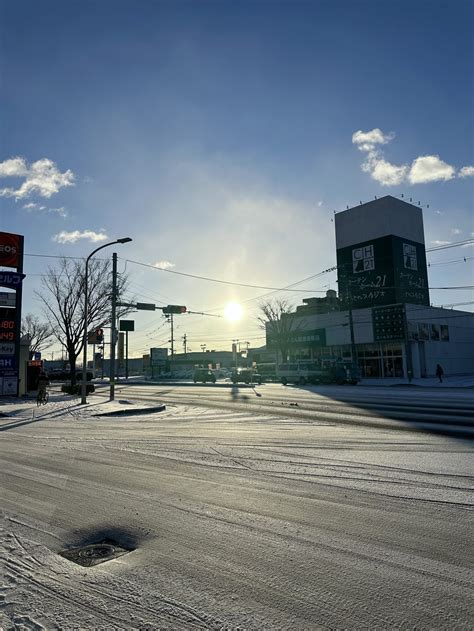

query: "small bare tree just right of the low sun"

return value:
[257, 298, 298, 361]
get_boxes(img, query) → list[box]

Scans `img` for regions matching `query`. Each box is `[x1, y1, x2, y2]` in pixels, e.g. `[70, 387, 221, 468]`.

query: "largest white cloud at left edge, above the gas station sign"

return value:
[0, 158, 74, 200]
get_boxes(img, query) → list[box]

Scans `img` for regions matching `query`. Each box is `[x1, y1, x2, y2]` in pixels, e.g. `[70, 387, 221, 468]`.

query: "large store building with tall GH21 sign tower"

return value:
[267, 196, 474, 378]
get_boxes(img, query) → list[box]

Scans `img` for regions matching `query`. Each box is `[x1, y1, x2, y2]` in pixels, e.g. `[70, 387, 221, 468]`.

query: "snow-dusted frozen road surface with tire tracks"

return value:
[0, 386, 474, 631]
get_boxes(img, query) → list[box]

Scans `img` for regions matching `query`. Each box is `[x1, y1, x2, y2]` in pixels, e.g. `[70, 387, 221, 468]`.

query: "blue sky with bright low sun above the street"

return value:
[0, 0, 474, 354]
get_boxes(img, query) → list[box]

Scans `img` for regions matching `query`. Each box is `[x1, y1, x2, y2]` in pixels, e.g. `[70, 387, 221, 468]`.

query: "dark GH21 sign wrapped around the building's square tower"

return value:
[337, 235, 430, 309]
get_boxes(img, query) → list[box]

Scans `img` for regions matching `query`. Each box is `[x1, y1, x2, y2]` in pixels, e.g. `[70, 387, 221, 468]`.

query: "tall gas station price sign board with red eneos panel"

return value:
[0, 232, 24, 396]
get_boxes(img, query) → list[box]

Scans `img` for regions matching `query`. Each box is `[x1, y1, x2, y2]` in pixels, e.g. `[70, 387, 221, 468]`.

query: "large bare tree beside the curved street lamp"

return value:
[36, 258, 128, 384]
